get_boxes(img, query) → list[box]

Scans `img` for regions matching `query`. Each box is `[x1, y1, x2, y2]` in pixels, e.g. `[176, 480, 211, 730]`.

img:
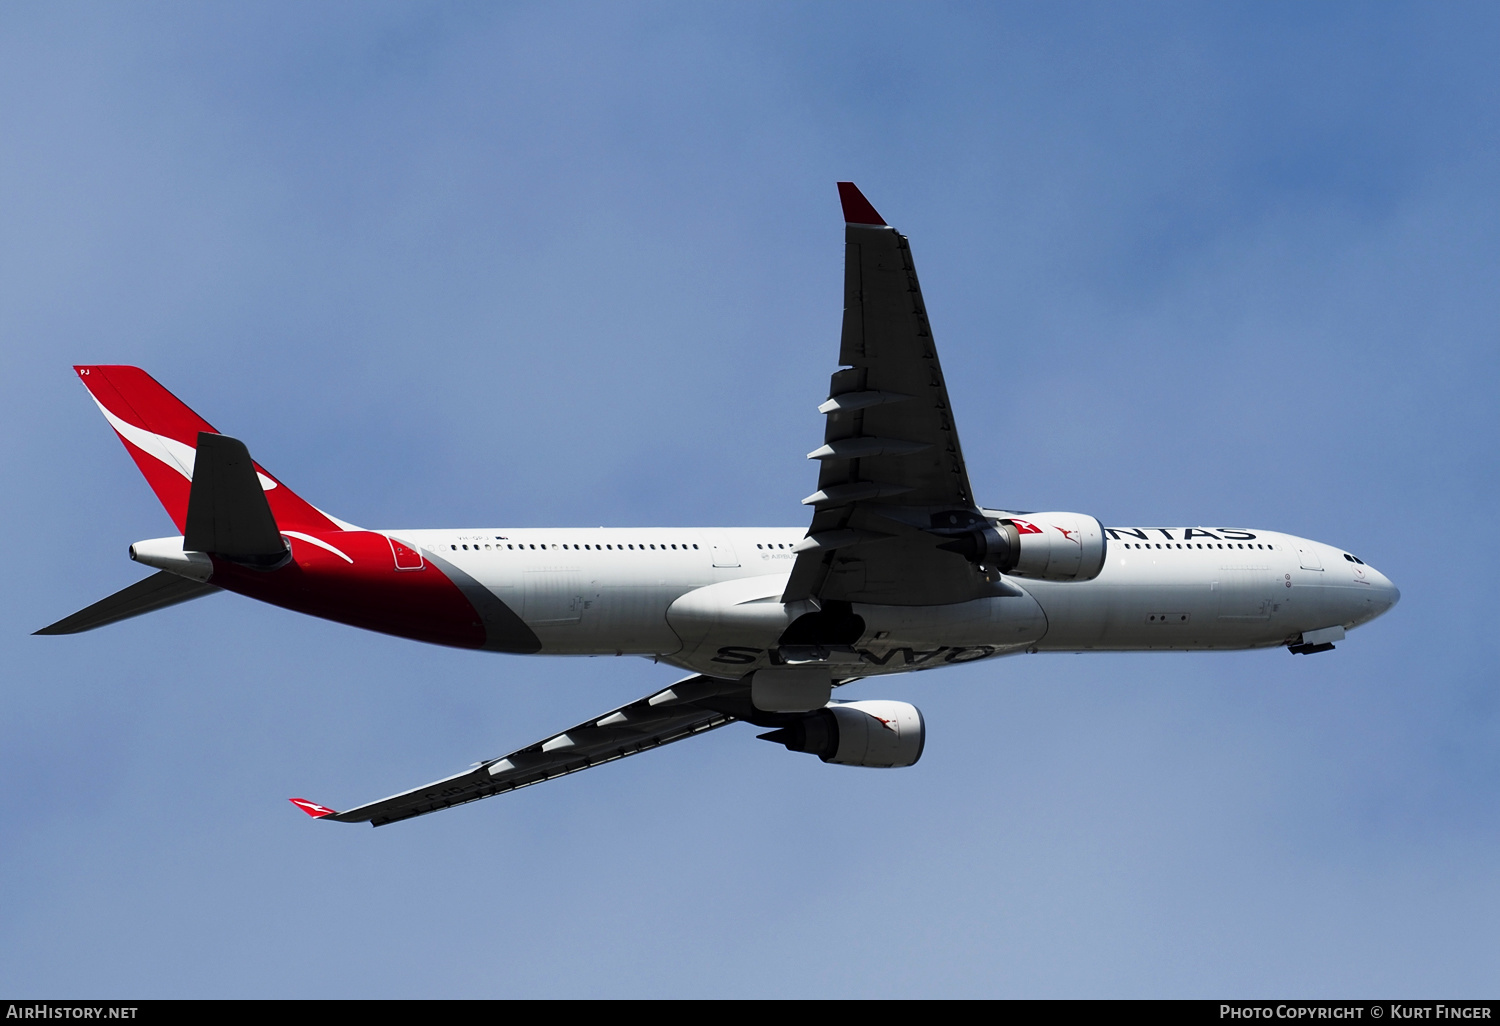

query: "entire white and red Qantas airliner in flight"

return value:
[36, 182, 1400, 827]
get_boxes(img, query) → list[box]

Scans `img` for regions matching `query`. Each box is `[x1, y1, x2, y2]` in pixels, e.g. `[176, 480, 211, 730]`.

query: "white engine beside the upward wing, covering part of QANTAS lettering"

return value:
[933, 513, 1106, 581]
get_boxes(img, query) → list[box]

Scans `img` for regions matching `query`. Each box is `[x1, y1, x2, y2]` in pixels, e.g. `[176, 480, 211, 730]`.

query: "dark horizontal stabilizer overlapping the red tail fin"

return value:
[183, 431, 287, 563]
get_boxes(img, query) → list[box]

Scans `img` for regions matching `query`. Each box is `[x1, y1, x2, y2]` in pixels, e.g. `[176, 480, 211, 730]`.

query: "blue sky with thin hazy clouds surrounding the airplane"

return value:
[0, 3, 1500, 998]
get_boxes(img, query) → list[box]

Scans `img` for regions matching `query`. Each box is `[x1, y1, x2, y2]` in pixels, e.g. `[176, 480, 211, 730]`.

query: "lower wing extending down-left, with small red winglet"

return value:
[313, 677, 750, 827]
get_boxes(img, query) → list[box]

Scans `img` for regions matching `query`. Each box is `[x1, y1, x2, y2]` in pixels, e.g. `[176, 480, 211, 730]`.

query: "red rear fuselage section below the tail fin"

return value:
[213, 531, 485, 648]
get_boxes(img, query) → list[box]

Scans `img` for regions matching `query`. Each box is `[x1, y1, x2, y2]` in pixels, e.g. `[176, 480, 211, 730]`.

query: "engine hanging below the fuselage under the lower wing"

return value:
[761, 699, 927, 768]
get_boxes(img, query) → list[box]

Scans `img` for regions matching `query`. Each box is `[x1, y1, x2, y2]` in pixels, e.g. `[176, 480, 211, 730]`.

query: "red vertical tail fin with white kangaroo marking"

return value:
[74, 366, 345, 531]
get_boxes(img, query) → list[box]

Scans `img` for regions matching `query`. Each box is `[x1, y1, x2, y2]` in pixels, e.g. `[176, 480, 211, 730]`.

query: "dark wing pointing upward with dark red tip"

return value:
[782, 182, 986, 605]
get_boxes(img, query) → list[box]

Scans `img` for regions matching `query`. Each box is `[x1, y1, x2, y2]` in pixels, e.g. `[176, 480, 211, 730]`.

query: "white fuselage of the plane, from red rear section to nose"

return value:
[390, 528, 1400, 677]
